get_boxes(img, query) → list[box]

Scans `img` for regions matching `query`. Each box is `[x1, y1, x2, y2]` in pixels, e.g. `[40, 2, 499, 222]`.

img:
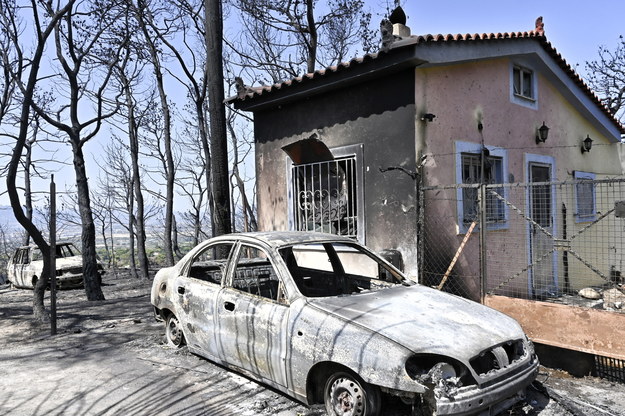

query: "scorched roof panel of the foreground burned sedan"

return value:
[211, 231, 356, 248]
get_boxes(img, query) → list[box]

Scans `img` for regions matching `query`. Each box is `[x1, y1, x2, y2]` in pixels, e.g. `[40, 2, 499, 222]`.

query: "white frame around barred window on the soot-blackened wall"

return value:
[286, 144, 366, 244]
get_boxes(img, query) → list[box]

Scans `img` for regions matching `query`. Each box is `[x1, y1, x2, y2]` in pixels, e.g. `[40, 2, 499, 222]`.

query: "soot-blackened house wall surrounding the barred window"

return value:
[254, 68, 417, 275]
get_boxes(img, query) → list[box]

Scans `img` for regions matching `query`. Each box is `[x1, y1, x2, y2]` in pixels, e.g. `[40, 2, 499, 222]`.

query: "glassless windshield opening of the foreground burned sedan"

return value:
[280, 242, 404, 297]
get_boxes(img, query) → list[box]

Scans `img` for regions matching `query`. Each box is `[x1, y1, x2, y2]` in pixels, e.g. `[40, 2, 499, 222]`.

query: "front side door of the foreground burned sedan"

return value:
[216, 244, 289, 387]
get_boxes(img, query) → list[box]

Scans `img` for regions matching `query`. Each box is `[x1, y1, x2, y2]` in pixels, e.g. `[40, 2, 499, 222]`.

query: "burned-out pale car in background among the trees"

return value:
[7, 242, 104, 289]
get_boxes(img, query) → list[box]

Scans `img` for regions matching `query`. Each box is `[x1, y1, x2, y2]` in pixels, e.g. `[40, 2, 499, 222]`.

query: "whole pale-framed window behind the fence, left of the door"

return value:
[456, 142, 507, 233]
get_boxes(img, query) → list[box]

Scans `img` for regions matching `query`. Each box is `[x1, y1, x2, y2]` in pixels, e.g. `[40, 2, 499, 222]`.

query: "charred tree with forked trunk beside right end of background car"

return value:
[25, 1, 130, 300]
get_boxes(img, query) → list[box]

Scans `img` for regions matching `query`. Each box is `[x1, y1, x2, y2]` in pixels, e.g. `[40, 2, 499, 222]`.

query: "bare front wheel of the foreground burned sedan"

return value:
[324, 372, 380, 416]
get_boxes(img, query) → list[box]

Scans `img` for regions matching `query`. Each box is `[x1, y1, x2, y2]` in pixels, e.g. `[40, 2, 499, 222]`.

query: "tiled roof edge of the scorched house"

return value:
[228, 24, 625, 134]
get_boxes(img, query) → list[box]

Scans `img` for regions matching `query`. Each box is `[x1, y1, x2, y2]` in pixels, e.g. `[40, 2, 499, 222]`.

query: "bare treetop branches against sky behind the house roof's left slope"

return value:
[229, 0, 376, 83]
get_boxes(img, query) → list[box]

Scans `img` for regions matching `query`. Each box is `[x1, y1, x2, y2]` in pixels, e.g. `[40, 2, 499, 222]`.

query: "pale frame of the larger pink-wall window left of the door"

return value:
[455, 141, 509, 234]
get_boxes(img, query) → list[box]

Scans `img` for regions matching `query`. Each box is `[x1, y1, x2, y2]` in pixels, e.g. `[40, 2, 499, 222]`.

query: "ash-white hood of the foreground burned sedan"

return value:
[309, 285, 524, 360]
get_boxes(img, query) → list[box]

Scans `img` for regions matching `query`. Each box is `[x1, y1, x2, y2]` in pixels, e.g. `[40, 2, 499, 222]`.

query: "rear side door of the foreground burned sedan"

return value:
[174, 242, 234, 361]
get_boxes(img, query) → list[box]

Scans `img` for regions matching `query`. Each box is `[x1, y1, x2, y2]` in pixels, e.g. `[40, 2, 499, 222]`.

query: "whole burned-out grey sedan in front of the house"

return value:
[151, 232, 538, 416]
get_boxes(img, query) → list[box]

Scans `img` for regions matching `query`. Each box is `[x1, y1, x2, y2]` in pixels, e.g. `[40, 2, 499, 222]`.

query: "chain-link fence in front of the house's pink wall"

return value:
[421, 178, 625, 311]
